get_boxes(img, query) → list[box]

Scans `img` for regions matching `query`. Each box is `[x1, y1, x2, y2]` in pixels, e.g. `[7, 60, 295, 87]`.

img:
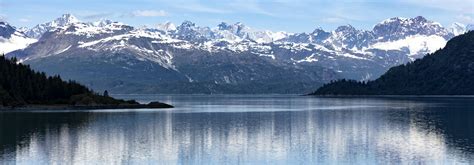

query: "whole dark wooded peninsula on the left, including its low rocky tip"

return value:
[0, 56, 173, 110]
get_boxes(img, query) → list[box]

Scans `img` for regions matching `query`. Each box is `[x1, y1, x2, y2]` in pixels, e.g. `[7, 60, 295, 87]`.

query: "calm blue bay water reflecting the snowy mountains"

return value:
[0, 95, 474, 164]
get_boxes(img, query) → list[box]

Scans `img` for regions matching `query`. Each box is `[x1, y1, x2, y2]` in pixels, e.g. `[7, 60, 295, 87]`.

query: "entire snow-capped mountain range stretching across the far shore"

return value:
[0, 14, 474, 93]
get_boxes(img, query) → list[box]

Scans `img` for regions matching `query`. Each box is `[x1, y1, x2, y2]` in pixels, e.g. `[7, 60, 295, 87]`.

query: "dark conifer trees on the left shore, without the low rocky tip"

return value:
[0, 56, 136, 106]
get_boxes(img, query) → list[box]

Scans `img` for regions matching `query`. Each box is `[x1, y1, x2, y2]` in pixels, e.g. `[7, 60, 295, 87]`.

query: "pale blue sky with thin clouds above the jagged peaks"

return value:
[0, 0, 474, 32]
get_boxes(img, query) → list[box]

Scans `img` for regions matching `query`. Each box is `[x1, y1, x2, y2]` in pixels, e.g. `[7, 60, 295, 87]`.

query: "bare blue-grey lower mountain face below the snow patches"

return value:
[23, 47, 335, 93]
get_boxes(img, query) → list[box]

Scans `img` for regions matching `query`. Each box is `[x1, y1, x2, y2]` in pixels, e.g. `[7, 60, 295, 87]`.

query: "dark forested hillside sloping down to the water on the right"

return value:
[313, 31, 474, 95]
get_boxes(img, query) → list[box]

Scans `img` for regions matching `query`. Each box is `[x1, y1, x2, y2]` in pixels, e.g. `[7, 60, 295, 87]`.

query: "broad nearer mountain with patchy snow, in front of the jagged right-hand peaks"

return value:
[8, 16, 336, 93]
